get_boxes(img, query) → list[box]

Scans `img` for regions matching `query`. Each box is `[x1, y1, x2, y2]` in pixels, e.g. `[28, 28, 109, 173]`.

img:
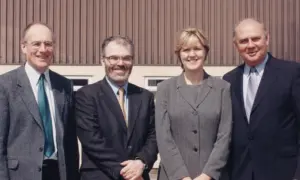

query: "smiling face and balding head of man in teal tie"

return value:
[21, 24, 54, 73]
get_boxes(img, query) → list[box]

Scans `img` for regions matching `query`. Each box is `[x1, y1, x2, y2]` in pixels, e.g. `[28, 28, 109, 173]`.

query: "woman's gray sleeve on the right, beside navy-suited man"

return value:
[203, 84, 232, 179]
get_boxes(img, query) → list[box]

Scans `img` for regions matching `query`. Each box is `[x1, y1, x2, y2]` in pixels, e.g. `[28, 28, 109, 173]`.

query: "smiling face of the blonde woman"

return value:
[179, 36, 206, 71]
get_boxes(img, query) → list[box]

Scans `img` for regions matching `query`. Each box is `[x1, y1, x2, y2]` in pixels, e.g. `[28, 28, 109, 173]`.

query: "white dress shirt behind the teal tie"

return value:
[25, 63, 57, 160]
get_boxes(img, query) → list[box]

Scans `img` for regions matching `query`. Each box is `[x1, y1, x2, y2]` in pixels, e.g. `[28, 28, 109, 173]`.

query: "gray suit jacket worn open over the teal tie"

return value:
[0, 66, 78, 180]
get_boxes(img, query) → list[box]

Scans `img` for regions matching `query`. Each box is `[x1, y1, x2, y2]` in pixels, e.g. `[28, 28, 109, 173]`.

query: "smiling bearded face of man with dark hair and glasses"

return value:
[103, 41, 133, 86]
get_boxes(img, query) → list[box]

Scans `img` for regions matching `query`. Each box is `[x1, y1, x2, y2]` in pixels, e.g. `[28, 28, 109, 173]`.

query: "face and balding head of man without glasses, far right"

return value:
[234, 19, 269, 66]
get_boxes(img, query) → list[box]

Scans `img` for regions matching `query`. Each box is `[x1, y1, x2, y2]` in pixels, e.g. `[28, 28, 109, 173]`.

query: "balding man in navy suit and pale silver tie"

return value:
[223, 19, 300, 180]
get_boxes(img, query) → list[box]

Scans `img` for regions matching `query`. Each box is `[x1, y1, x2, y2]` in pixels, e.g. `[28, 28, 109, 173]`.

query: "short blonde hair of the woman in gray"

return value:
[175, 28, 209, 67]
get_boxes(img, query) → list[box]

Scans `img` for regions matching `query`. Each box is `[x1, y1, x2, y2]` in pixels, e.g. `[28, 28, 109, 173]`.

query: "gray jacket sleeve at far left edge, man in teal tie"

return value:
[0, 82, 10, 180]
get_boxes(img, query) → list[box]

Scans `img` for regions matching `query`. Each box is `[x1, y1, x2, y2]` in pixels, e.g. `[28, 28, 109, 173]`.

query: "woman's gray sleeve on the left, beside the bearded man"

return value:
[155, 84, 190, 180]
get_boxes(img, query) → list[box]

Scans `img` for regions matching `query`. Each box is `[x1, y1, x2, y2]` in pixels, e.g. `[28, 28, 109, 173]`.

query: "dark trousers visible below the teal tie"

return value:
[42, 160, 60, 180]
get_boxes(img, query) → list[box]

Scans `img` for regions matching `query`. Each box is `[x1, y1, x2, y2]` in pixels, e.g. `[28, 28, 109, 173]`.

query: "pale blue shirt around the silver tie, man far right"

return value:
[243, 54, 268, 102]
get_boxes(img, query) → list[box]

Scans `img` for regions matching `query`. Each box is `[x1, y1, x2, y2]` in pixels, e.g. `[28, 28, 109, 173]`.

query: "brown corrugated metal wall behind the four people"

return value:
[0, 0, 300, 65]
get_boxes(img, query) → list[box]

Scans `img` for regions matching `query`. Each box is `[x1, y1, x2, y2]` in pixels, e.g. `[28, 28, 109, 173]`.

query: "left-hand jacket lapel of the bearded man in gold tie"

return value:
[100, 78, 127, 133]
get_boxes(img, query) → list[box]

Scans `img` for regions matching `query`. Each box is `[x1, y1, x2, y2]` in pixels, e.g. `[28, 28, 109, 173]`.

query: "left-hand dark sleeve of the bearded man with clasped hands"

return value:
[75, 90, 125, 179]
